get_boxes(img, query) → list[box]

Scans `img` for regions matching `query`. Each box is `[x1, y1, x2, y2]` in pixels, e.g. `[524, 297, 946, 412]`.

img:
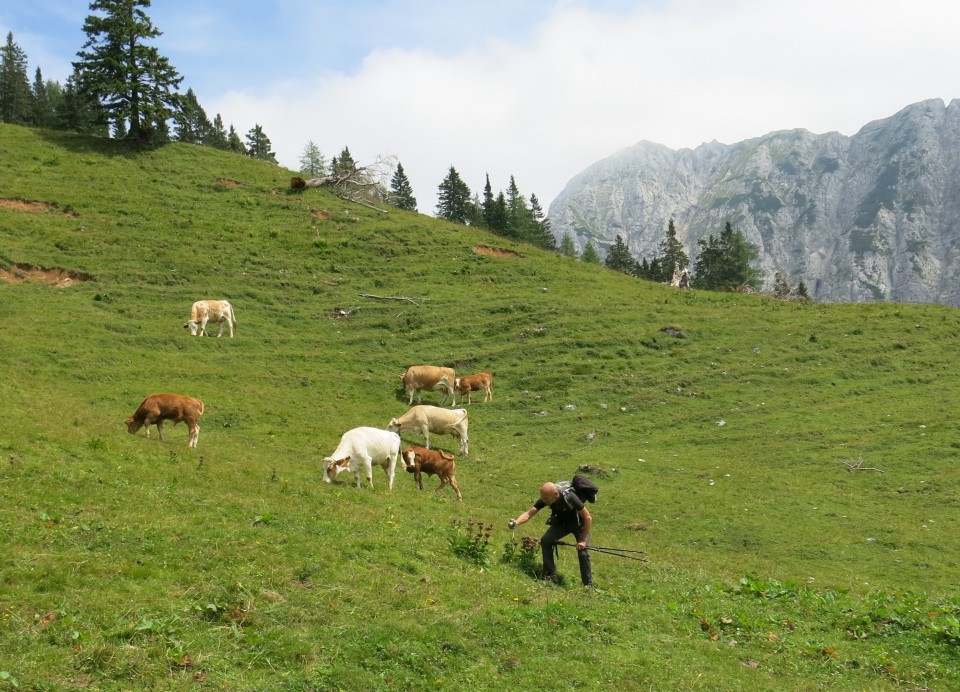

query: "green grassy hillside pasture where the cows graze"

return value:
[0, 125, 960, 690]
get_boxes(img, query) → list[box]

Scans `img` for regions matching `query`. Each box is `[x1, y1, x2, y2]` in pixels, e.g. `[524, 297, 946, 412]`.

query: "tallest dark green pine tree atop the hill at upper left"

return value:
[74, 0, 183, 143]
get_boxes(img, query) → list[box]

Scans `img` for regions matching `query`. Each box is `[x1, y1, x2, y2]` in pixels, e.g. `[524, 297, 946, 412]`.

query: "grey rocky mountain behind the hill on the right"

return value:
[549, 99, 960, 306]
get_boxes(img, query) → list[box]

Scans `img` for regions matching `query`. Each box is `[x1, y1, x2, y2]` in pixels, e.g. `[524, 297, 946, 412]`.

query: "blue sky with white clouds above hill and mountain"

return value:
[0, 0, 960, 214]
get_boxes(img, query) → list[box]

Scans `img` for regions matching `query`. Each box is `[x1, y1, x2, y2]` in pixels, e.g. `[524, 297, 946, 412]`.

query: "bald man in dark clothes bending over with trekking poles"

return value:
[508, 483, 593, 586]
